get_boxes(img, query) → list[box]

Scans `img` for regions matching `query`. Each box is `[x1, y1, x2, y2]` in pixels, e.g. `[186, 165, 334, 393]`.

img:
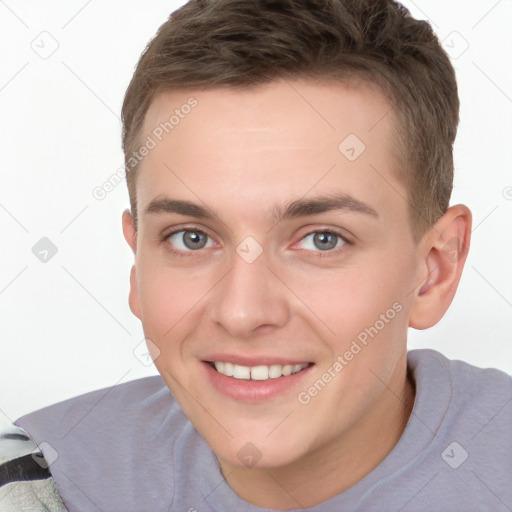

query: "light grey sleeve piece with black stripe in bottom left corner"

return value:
[0, 425, 68, 512]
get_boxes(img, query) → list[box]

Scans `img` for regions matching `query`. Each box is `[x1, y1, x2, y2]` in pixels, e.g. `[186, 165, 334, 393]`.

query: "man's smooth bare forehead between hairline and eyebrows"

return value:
[137, 77, 405, 226]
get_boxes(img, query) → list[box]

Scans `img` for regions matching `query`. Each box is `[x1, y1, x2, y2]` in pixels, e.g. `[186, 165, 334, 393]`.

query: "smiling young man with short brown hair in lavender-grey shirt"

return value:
[0, 0, 512, 512]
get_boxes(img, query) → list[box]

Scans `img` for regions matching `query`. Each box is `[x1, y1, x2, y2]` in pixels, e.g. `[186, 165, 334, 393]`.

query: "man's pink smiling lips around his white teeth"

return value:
[200, 356, 314, 403]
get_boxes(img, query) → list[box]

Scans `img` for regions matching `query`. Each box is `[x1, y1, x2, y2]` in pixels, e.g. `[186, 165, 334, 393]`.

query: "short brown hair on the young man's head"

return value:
[122, 0, 459, 235]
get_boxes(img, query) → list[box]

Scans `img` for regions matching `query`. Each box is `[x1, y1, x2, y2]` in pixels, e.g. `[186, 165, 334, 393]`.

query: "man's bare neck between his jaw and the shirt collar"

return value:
[219, 356, 415, 510]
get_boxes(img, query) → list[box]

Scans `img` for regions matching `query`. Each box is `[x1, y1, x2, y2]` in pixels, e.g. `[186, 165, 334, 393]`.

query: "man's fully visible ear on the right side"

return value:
[409, 205, 471, 329]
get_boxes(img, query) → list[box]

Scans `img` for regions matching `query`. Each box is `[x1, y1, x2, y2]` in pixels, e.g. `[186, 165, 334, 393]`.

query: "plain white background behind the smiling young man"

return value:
[0, 0, 512, 421]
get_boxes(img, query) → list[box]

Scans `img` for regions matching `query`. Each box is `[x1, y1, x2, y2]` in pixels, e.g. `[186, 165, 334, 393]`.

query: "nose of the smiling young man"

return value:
[210, 249, 290, 339]
